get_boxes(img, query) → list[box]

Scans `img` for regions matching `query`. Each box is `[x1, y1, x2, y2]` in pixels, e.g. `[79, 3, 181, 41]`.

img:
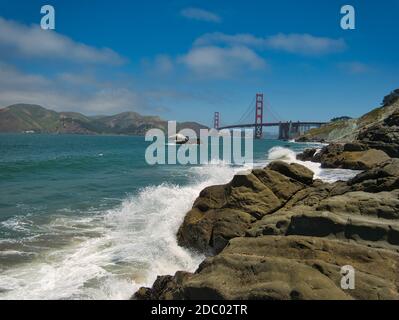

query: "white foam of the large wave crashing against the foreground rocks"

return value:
[0, 164, 239, 299]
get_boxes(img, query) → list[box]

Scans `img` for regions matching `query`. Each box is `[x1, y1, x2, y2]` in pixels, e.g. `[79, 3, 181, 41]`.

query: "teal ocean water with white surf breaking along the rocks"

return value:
[0, 134, 356, 299]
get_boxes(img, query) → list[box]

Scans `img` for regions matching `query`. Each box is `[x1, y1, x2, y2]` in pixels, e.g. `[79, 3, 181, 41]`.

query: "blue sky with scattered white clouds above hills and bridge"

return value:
[0, 0, 399, 125]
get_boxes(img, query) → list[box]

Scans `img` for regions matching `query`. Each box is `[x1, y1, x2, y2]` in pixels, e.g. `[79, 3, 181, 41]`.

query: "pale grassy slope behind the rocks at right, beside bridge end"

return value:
[297, 89, 399, 142]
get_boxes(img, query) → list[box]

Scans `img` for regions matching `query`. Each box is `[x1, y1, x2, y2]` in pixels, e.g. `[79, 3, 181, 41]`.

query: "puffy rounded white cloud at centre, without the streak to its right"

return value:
[178, 46, 266, 78]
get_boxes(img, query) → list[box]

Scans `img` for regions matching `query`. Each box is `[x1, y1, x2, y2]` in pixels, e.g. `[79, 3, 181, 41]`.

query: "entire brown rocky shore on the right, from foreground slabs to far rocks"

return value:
[133, 92, 399, 300]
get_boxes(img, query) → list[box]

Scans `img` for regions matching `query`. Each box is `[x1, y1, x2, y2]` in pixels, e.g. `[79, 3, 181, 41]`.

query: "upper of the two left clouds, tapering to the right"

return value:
[0, 17, 124, 65]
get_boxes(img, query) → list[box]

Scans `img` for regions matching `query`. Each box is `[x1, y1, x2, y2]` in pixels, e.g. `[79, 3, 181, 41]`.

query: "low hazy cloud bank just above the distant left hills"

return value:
[0, 64, 149, 114]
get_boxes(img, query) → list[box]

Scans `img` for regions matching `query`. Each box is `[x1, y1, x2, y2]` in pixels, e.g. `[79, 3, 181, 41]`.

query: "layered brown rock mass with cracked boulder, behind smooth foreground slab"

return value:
[178, 159, 399, 253]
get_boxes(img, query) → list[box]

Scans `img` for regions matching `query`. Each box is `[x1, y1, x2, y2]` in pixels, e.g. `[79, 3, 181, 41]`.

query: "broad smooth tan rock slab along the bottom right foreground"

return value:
[136, 236, 399, 300]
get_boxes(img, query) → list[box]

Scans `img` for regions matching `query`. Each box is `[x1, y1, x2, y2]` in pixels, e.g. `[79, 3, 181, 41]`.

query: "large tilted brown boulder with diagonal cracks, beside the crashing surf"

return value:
[177, 162, 313, 253]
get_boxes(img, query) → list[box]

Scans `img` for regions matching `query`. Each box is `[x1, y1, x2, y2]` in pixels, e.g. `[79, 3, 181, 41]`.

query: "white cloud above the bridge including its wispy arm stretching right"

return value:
[173, 32, 346, 78]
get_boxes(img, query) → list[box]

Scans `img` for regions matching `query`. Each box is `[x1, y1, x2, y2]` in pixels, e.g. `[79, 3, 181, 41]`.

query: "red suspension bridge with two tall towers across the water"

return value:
[213, 93, 326, 140]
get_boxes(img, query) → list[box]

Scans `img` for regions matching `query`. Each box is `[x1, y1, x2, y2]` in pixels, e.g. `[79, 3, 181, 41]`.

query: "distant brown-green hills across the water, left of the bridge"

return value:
[0, 104, 211, 135]
